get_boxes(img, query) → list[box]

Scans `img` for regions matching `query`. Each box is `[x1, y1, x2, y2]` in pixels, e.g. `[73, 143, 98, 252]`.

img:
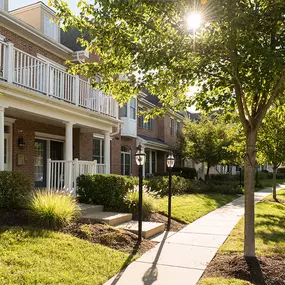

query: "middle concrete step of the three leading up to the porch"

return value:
[80, 212, 132, 226]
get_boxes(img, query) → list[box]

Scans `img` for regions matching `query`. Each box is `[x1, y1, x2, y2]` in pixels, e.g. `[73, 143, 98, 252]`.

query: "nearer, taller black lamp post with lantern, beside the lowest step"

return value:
[135, 144, 146, 242]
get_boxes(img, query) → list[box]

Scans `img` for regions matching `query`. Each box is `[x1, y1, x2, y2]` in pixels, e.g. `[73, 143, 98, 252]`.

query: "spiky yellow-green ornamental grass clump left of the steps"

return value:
[27, 190, 80, 228]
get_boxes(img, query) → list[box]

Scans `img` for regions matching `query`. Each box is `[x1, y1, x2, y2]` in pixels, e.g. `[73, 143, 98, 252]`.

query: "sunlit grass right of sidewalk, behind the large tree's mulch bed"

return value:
[219, 190, 285, 257]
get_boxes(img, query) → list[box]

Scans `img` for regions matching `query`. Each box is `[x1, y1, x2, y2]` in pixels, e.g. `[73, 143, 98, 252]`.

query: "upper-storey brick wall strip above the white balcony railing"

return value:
[0, 26, 65, 64]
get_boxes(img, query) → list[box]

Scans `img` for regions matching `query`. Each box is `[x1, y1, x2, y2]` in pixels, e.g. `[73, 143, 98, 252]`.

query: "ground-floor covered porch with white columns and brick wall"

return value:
[0, 106, 115, 193]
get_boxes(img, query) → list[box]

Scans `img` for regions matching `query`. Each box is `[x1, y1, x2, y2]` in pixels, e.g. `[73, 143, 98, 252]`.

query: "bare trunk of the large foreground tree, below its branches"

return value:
[244, 129, 257, 257]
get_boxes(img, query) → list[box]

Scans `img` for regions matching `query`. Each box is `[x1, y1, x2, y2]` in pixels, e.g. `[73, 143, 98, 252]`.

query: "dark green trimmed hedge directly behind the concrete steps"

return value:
[77, 174, 138, 210]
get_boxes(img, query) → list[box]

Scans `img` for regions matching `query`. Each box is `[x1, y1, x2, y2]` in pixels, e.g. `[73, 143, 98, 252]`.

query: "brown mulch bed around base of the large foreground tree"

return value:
[203, 254, 285, 285]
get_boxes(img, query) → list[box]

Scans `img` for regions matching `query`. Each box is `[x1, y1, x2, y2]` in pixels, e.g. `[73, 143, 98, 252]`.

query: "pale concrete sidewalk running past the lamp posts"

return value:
[102, 186, 285, 285]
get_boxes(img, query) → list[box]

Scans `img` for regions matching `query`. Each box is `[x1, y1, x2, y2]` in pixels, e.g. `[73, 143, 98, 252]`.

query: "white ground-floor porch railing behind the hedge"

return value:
[47, 159, 106, 195]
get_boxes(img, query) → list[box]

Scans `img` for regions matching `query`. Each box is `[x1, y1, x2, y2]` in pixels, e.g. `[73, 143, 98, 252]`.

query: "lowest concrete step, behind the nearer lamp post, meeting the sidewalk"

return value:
[116, 221, 165, 238]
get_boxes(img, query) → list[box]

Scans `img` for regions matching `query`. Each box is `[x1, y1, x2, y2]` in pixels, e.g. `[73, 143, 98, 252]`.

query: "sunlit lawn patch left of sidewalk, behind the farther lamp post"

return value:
[157, 193, 238, 224]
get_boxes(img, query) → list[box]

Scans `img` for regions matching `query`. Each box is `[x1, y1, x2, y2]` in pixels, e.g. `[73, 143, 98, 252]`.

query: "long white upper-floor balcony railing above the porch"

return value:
[0, 41, 118, 119]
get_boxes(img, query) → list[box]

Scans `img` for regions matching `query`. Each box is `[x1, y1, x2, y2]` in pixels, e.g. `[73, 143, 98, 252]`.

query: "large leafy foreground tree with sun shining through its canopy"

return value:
[49, 0, 285, 256]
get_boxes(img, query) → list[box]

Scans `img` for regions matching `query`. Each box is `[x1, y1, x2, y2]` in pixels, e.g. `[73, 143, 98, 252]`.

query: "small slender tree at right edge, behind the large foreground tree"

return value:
[257, 106, 285, 200]
